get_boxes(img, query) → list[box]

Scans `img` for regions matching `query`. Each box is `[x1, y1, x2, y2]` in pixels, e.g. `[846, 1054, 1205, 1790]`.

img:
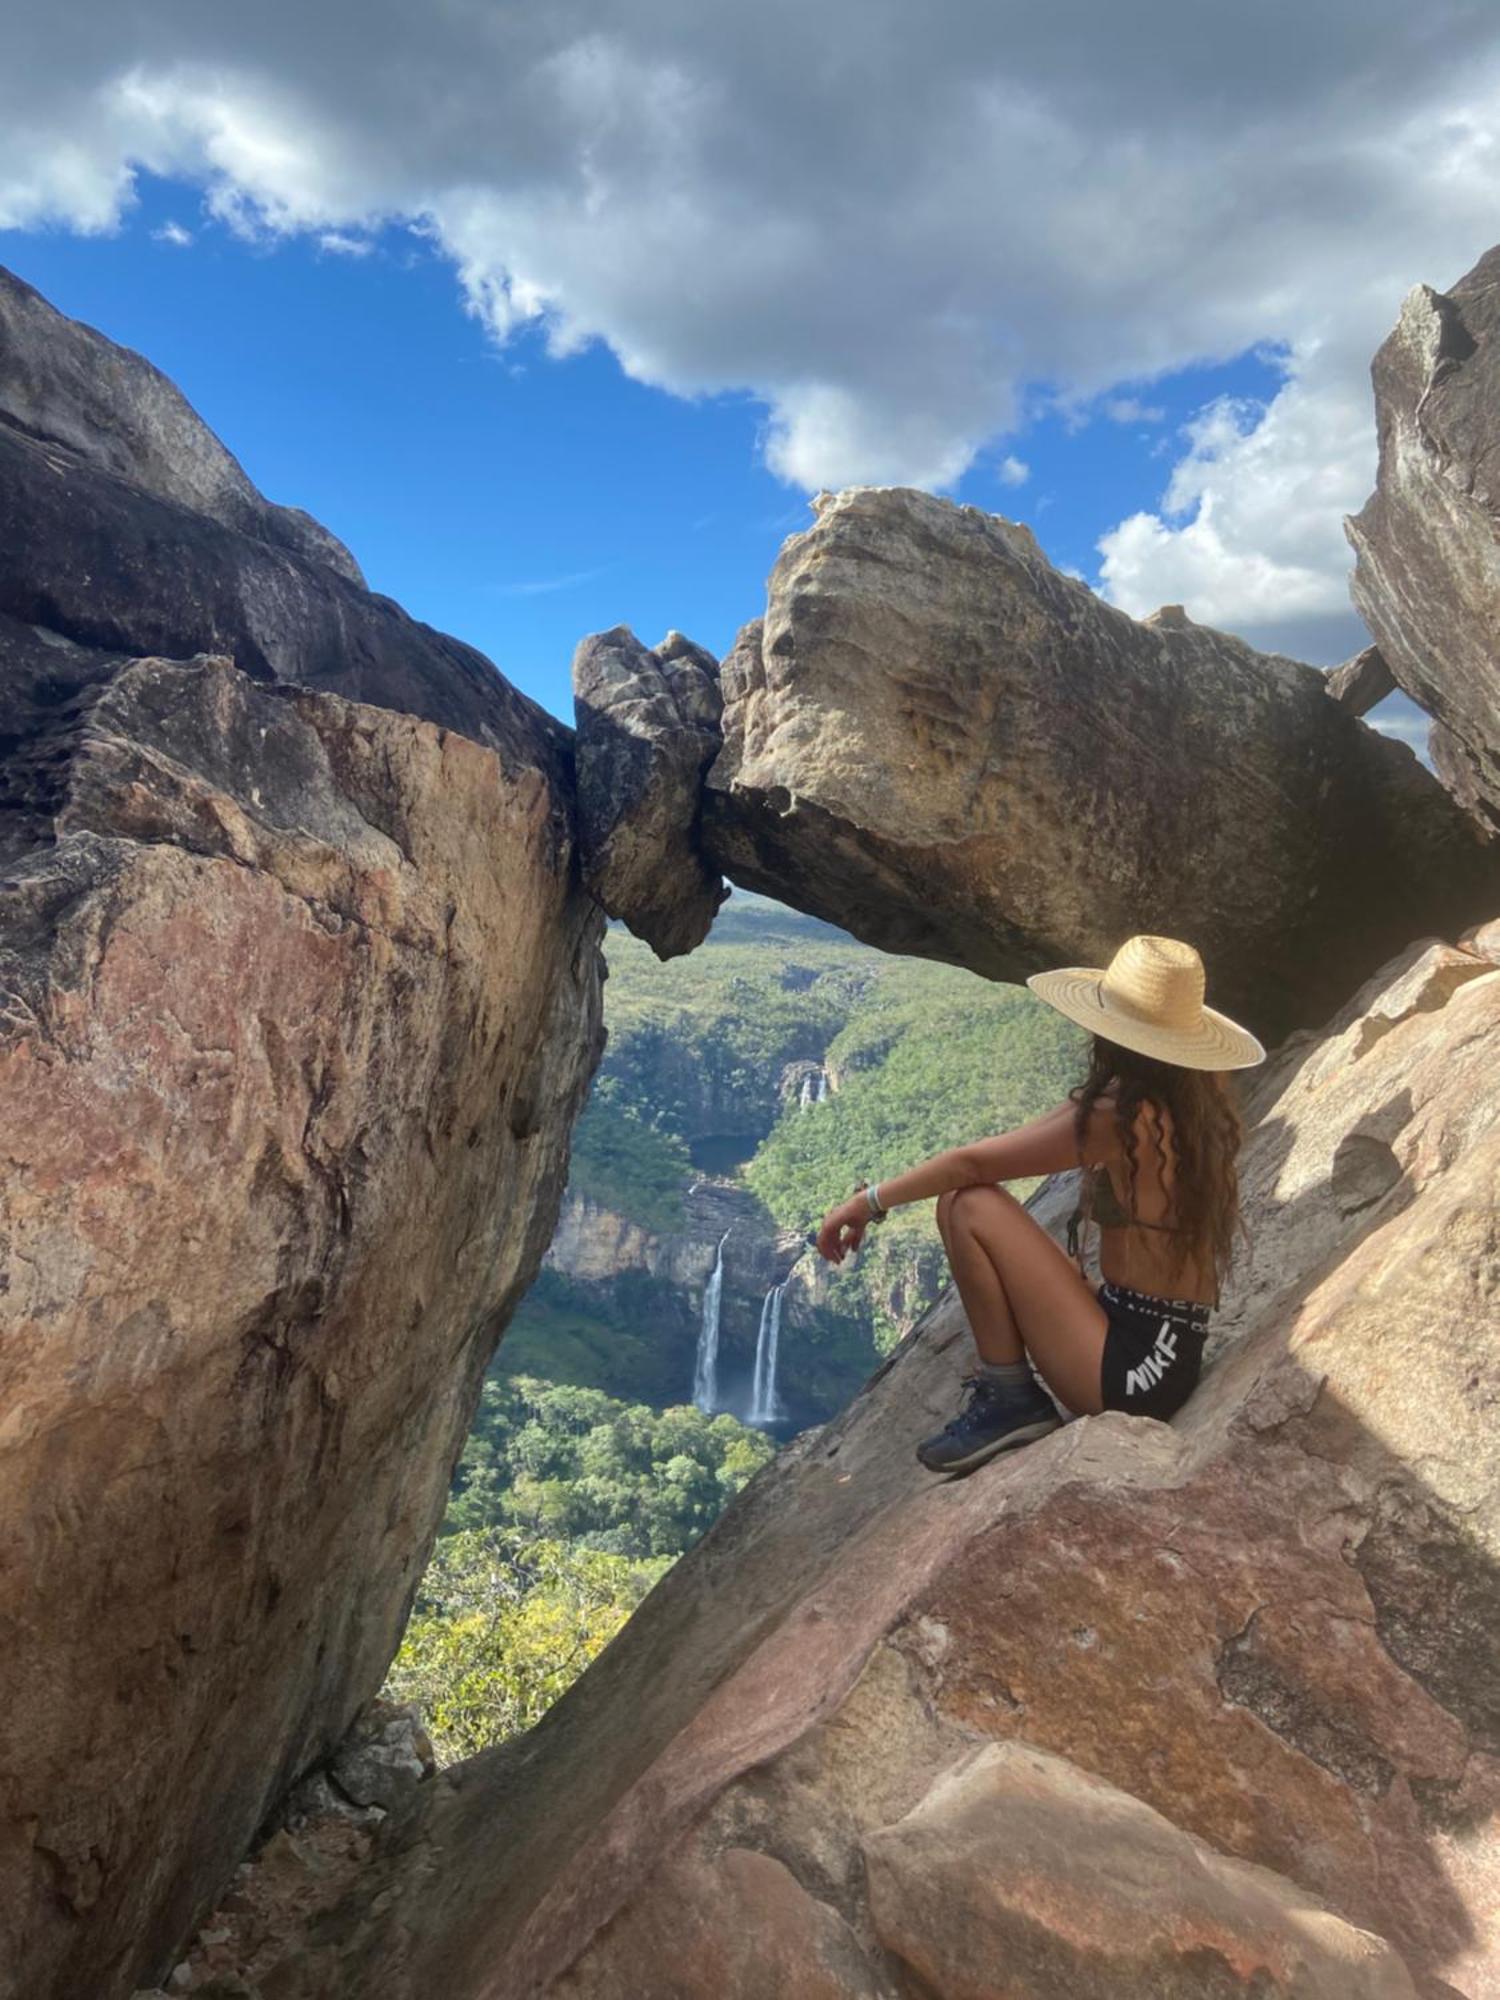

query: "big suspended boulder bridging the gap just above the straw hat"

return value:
[704, 488, 1500, 1040]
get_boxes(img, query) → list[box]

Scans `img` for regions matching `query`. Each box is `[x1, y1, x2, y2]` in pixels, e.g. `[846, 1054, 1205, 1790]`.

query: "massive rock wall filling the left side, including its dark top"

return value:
[0, 274, 600, 2000]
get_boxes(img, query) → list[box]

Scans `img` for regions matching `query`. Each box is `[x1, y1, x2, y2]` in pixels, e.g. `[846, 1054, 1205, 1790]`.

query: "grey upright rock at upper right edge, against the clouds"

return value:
[1346, 248, 1500, 832]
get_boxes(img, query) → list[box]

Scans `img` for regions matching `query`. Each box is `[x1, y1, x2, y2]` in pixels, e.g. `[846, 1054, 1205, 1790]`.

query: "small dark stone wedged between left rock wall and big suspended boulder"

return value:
[572, 626, 728, 958]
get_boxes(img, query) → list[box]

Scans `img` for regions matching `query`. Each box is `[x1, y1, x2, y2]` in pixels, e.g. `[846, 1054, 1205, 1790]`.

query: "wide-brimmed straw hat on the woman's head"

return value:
[1026, 938, 1266, 1070]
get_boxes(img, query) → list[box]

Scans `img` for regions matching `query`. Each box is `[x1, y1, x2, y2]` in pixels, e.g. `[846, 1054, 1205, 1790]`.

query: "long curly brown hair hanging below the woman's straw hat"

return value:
[1068, 1034, 1246, 1284]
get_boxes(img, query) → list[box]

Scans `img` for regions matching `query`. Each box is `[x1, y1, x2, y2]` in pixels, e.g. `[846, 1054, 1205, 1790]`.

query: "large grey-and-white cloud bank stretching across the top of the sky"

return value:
[0, 0, 1500, 644]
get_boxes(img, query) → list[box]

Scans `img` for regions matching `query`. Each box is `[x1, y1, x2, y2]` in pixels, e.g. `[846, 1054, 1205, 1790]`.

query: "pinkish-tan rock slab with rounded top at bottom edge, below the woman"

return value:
[864, 1744, 1416, 2000]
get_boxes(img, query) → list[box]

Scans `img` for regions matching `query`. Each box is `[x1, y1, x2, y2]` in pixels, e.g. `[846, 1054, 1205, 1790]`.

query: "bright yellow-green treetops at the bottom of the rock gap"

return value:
[384, 1528, 670, 1762]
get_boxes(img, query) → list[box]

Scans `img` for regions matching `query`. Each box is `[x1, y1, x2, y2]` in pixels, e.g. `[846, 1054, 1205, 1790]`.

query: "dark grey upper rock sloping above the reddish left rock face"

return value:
[0, 274, 572, 768]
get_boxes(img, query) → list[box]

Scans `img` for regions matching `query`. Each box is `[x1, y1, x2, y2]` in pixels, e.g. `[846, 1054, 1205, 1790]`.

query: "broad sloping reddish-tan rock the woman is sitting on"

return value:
[150, 928, 1500, 2000]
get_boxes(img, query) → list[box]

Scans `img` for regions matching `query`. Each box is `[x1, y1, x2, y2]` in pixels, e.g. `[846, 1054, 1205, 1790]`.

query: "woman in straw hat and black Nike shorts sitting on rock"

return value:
[818, 938, 1266, 1472]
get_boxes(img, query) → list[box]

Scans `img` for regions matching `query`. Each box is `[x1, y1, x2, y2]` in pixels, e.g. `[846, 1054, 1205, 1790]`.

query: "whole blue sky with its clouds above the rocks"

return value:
[0, 0, 1500, 752]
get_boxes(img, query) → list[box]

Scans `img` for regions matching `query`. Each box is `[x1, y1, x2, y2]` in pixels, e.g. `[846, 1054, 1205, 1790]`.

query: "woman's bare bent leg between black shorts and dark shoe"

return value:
[938, 1188, 1108, 1416]
